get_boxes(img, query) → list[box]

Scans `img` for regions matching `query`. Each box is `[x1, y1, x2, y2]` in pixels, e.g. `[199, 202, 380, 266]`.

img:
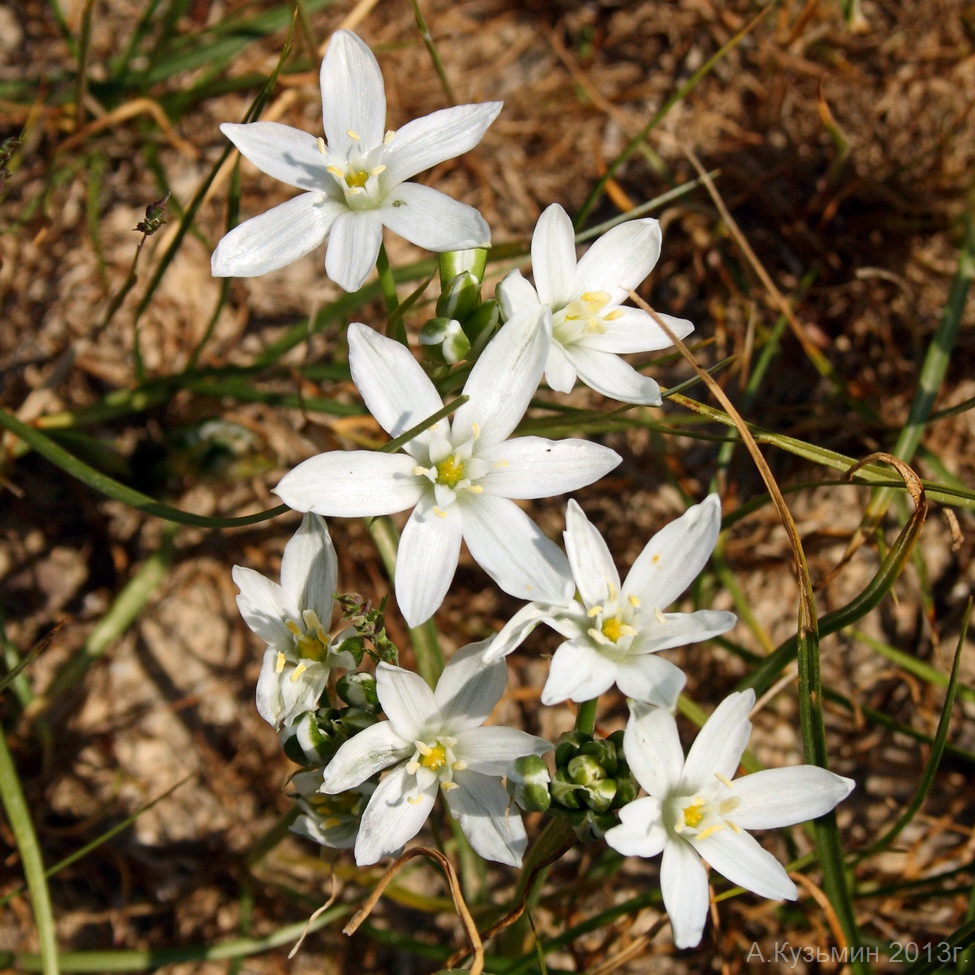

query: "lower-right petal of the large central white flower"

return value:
[463, 494, 572, 602]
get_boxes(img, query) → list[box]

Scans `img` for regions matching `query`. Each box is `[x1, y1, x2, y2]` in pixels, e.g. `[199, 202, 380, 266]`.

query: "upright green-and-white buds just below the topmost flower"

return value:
[420, 247, 500, 367]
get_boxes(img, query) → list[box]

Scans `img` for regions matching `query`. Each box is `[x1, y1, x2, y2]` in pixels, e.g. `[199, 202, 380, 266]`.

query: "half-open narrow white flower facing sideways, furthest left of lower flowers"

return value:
[233, 514, 355, 728]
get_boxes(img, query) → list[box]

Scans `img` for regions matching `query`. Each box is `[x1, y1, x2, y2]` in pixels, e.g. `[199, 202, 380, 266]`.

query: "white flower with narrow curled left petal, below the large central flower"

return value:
[485, 494, 736, 708]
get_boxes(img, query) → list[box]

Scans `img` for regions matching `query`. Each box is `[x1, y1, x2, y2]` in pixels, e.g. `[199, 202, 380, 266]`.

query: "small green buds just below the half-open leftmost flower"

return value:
[281, 671, 379, 767]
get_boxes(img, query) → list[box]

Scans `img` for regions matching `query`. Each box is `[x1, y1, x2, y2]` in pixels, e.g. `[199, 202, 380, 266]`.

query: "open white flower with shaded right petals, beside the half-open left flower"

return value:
[321, 644, 552, 866]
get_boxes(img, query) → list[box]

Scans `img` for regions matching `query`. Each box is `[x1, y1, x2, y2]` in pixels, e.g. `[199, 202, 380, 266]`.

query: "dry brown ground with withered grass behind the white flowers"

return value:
[0, 0, 975, 975]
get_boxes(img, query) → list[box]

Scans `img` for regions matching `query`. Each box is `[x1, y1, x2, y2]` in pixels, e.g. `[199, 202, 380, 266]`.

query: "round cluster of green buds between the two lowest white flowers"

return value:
[508, 731, 640, 840]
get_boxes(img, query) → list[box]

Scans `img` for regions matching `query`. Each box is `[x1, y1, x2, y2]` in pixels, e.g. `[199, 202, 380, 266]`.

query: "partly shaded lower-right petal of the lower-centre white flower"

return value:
[444, 771, 528, 867]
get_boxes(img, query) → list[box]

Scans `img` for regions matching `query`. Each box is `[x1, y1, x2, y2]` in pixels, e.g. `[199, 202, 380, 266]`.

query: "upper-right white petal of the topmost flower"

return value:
[383, 102, 501, 183]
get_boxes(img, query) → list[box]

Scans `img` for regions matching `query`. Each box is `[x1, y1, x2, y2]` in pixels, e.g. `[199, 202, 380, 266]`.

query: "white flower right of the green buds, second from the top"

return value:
[498, 203, 694, 406]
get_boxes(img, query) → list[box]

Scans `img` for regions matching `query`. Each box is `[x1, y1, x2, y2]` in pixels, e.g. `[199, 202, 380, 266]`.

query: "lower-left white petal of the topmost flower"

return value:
[210, 193, 345, 278]
